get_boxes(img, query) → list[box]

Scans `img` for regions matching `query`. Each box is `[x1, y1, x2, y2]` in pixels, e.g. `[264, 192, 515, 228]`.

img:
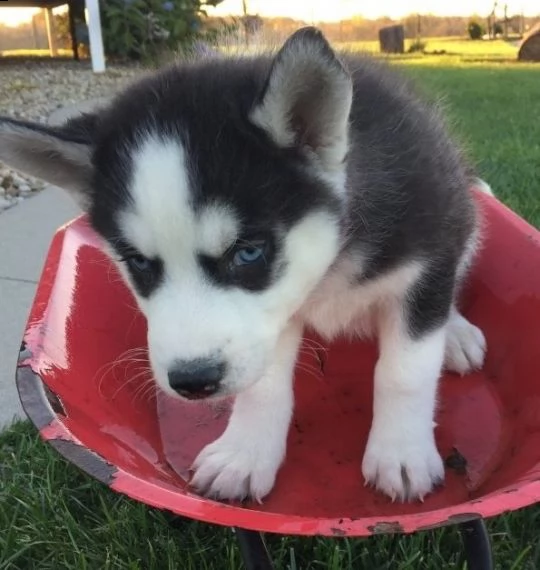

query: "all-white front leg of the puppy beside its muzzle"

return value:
[191, 323, 302, 502]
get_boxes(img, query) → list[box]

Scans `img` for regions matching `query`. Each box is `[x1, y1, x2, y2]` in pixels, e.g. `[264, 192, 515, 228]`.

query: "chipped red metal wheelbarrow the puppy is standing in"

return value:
[17, 190, 540, 570]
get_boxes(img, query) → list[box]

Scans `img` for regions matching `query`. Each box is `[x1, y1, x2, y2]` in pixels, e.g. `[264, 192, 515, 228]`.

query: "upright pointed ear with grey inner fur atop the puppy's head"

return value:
[251, 27, 352, 170]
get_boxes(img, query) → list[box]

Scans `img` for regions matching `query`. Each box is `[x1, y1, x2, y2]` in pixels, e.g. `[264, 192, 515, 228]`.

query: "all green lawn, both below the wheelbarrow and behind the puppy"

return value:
[0, 51, 540, 570]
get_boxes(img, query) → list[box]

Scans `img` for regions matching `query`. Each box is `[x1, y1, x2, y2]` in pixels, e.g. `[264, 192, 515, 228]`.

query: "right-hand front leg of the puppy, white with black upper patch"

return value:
[362, 264, 453, 500]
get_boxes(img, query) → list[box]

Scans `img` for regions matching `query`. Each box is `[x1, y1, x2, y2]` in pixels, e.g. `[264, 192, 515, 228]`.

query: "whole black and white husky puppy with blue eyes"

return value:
[0, 28, 486, 501]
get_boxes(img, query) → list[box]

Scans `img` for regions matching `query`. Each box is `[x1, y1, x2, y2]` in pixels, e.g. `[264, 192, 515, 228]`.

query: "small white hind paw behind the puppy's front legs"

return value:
[444, 313, 486, 376]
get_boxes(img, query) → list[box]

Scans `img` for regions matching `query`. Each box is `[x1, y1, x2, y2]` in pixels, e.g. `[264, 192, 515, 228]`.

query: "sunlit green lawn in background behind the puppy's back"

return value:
[396, 59, 540, 227]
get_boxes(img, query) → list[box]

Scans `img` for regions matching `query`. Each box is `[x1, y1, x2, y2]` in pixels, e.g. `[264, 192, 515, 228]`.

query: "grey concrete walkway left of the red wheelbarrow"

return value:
[0, 187, 80, 430]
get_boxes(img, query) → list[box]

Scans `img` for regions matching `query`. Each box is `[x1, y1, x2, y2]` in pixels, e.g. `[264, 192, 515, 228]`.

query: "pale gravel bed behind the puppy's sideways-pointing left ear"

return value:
[0, 58, 142, 214]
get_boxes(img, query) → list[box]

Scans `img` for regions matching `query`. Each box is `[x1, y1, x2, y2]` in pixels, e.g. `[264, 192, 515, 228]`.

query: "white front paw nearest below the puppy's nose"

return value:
[190, 430, 285, 503]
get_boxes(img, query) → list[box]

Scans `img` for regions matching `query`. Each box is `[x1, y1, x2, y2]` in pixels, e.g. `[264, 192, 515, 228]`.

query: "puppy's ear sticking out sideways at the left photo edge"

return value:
[0, 117, 93, 209]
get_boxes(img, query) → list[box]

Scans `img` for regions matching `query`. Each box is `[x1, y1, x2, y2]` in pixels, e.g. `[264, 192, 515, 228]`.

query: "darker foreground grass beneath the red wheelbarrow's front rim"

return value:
[4, 422, 540, 570]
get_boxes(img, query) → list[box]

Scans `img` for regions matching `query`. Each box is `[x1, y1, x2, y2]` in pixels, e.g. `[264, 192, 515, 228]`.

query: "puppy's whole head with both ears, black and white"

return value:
[0, 30, 351, 399]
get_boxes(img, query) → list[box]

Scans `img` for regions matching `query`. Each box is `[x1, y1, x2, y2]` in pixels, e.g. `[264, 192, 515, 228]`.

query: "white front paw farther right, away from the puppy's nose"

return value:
[362, 424, 444, 501]
